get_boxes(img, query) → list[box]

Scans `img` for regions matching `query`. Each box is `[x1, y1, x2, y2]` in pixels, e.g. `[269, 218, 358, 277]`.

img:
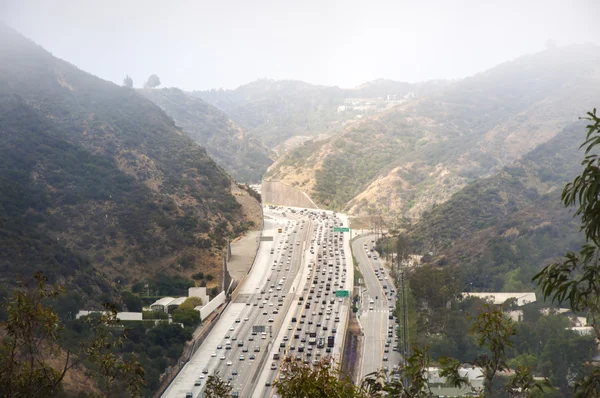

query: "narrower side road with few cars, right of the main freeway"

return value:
[352, 235, 401, 378]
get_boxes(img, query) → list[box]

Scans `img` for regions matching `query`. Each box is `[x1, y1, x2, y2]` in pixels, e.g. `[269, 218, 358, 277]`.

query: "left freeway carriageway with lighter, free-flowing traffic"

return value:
[163, 209, 308, 397]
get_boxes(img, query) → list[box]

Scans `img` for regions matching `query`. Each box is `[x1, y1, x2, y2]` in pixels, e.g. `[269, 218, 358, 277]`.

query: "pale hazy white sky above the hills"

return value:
[0, 0, 600, 89]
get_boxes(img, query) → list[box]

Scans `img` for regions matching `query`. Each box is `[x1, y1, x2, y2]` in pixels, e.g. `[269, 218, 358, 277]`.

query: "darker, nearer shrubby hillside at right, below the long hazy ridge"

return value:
[409, 123, 586, 291]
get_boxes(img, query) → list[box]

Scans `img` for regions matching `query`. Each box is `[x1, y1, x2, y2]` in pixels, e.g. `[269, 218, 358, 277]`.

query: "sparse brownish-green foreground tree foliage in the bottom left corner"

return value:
[0, 273, 144, 397]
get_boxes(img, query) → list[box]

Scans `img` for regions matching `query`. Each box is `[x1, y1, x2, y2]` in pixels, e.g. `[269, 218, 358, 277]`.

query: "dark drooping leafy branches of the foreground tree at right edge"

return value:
[533, 109, 600, 396]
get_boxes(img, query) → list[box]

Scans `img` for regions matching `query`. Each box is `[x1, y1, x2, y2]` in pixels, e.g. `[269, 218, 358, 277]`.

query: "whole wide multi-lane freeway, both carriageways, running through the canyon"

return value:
[163, 208, 353, 397]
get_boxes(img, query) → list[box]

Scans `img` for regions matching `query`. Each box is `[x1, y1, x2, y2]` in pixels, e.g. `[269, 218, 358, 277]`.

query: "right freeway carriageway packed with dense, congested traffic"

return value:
[252, 211, 353, 397]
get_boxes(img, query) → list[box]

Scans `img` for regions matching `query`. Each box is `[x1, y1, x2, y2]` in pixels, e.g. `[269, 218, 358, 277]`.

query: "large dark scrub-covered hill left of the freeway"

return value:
[0, 25, 255, 303]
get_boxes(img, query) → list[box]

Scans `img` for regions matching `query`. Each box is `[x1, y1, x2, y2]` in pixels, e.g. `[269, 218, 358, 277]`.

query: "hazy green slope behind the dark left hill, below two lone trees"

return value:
[138, 88, 273, 183]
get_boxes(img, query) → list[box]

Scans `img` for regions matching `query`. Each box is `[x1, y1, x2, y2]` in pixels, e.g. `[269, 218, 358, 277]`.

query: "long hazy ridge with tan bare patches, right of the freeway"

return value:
[267, 45, 600, 218]
